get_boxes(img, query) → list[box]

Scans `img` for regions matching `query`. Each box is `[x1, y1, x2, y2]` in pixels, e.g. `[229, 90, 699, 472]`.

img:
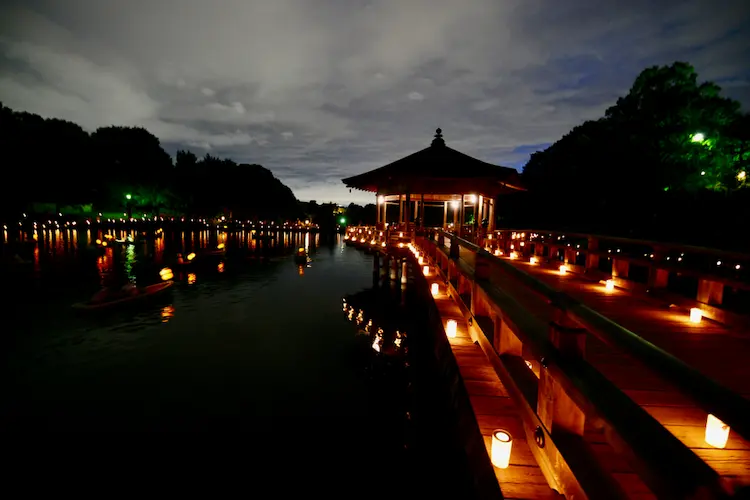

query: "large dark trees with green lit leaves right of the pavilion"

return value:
[516, 62, 750, 250]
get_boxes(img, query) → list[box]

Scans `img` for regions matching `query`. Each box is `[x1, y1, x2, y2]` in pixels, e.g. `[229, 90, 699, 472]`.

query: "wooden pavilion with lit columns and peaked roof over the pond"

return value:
[342, 129, 524, 236]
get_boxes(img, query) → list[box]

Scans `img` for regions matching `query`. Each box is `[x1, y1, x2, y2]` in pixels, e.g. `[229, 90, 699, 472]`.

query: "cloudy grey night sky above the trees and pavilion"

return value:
[0, 0, 750, 202]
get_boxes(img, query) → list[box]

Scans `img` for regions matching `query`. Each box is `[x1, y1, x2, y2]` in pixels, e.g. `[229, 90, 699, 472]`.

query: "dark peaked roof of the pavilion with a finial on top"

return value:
[342, 129, 525, 196]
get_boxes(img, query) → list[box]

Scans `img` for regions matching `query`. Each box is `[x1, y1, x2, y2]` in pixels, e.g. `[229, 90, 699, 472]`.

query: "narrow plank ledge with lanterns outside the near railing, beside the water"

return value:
[435, 294, 561, 499]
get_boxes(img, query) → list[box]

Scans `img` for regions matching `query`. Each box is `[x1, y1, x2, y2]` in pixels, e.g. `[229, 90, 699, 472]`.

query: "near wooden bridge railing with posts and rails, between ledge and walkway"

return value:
[417, 231, 750, 499]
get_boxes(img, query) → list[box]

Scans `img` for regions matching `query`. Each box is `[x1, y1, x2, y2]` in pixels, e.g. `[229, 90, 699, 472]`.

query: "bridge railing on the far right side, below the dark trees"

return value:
[477, 229, 750, 328]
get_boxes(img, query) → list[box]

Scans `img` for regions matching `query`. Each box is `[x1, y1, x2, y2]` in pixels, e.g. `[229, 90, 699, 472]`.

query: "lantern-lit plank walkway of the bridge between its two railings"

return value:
[500, 260, 750, 484]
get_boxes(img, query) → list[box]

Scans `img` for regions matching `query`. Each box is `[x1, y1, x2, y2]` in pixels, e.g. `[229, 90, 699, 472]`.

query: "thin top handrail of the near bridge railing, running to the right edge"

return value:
[441, 231, 750, 440]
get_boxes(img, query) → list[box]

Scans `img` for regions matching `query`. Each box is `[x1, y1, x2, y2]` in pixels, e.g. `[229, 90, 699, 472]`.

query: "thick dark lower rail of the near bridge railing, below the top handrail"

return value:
[430, 238, 729, 498]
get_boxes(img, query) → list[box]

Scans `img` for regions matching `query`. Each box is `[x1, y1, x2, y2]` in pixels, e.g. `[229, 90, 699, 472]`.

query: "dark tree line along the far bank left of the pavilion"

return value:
[0, 104, 302, 219]
